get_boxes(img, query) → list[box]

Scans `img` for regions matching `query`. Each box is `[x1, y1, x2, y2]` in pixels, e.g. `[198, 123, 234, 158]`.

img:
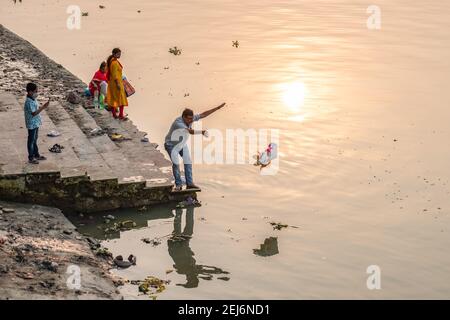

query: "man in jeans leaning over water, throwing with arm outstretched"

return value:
[164, 103, 225, 191]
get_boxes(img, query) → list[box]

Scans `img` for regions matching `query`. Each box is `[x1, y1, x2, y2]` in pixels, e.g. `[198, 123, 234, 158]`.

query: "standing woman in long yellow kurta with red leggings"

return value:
[106, 48, 128, 120]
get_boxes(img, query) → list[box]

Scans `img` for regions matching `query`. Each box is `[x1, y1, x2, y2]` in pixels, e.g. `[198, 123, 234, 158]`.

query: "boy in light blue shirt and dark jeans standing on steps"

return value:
[23, 82, 50, 164]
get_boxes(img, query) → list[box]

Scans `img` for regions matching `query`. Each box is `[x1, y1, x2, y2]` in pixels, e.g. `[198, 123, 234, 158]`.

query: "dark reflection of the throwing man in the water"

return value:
[167, 207, 228, 288]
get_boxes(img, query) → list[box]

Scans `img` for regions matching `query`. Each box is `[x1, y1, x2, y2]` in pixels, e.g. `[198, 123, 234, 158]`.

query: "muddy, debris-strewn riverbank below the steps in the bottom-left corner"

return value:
[0, 201, 121, 299]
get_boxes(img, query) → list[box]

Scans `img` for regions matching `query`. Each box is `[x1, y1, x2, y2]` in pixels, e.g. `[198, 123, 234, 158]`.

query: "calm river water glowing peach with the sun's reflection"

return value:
[0, 0, 450, 299]
